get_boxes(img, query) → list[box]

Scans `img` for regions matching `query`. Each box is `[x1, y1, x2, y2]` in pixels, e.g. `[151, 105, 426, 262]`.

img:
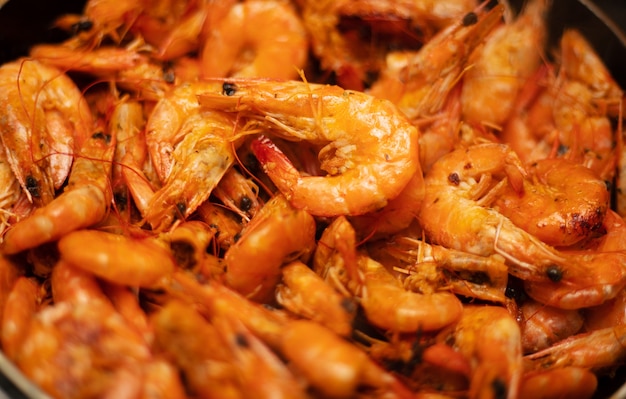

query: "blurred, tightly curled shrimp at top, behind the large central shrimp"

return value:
[200, 0, 308, 79]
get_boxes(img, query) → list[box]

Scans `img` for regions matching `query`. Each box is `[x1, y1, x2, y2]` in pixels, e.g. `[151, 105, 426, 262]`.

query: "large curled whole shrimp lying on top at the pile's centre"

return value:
[198, 81, 419, 216]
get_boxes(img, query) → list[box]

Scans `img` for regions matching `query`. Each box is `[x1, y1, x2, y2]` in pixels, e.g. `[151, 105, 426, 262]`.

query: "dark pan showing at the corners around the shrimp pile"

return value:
[0, 0, 626, 399]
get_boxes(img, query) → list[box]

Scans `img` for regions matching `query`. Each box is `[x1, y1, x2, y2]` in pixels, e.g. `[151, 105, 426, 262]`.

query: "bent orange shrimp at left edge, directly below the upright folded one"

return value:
[1, 115, 116, 254]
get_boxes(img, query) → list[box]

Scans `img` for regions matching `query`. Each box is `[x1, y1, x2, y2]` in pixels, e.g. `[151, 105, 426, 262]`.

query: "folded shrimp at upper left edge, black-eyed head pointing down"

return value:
[0, 59, 92, 206]
